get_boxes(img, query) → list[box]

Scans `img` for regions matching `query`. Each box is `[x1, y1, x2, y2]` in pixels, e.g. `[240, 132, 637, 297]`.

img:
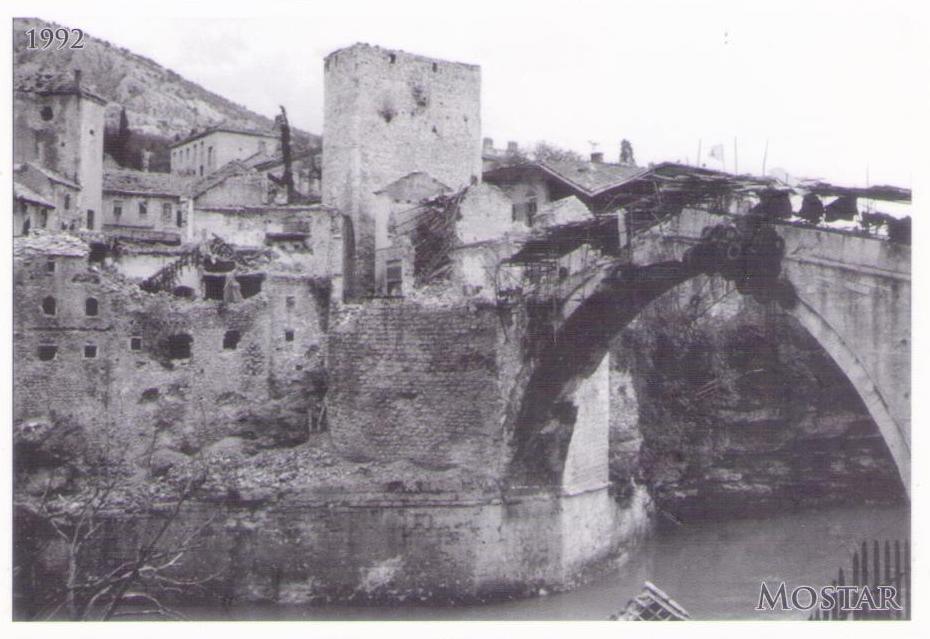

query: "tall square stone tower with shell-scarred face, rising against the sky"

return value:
[322, 44, 481, 298]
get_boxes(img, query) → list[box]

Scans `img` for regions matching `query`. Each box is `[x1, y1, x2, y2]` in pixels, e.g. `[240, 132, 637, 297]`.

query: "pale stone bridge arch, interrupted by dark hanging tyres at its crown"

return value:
[508, 209, 911, 495]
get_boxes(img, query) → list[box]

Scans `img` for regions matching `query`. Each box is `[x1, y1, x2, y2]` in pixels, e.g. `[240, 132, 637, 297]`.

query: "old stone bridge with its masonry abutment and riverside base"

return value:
[300, 204, 910, 599]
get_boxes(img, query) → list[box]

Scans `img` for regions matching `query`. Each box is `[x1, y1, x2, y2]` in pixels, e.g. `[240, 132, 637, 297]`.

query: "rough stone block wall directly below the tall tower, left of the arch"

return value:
[327, 300, 505, 475]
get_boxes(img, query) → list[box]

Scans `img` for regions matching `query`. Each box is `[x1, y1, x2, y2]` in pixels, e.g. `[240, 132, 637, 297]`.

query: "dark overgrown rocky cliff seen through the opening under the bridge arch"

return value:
[611, 277, 904, 520]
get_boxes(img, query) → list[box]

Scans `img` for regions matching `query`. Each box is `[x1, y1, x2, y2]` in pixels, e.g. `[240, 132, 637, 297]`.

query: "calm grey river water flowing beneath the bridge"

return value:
[186, 506, 910, 621]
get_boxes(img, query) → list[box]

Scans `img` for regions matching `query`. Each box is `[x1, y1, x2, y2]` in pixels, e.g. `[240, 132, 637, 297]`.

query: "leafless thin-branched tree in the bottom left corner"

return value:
[15, 424, 218, 621]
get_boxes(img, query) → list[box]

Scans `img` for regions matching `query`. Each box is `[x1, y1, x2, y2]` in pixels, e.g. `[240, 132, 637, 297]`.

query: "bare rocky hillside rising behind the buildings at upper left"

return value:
[13, 18, 320, 170]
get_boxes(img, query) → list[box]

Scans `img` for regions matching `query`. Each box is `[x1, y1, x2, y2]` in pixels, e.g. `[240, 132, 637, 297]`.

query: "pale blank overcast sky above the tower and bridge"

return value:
[18, 0, 930, 186]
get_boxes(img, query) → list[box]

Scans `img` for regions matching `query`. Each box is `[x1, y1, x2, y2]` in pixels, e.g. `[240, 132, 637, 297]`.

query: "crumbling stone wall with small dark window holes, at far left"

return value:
[14, 248, 329, 466]
